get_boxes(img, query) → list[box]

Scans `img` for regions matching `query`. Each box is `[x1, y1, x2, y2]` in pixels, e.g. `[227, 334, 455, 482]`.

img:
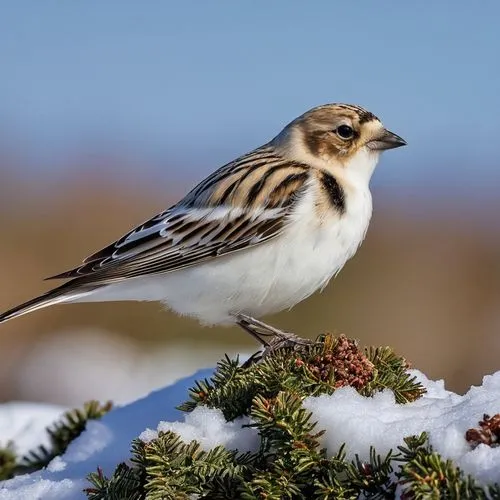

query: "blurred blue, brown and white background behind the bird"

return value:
[0, 0, 500, 405]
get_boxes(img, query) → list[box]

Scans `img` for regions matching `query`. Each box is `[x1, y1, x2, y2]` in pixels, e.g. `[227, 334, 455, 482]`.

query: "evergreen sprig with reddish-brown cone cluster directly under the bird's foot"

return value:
[179, 335, 424, 420]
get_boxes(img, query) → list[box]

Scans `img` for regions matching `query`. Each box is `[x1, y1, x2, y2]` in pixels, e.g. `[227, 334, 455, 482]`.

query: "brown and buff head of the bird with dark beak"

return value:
[275, 104, 406, 183]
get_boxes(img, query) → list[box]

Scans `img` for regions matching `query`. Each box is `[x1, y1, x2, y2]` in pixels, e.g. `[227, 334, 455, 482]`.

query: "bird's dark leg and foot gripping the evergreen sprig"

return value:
[236, 314, 312, 367]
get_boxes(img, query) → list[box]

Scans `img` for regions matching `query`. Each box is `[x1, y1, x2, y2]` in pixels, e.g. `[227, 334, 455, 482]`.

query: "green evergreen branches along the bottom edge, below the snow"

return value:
[85, 428, 500, 500]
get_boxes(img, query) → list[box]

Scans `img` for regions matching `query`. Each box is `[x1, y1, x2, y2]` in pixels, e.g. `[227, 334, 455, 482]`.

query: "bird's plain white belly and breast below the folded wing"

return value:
[82, 184, 372, 324]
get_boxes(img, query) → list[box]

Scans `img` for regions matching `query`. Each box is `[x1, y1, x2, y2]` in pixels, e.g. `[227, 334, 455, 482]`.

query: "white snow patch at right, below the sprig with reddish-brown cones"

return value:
[304, 370, 500, 484]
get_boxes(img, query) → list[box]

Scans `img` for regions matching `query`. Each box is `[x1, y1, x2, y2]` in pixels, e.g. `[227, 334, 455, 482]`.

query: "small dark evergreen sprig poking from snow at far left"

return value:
[0, 401, 112, 479]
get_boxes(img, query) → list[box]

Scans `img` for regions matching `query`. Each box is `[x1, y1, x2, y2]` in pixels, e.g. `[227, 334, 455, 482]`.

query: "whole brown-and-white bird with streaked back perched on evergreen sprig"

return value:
[0, 103, 406, 342]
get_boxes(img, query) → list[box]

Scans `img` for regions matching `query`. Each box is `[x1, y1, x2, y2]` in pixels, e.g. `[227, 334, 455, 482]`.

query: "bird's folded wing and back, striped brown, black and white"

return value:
[47, 147, 308, 285]
